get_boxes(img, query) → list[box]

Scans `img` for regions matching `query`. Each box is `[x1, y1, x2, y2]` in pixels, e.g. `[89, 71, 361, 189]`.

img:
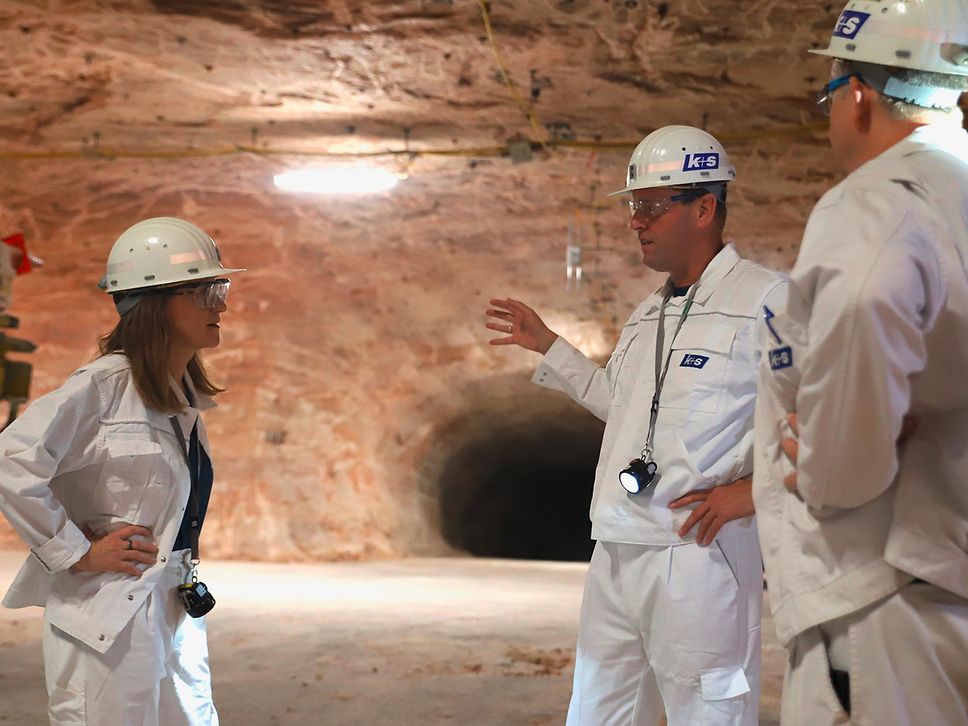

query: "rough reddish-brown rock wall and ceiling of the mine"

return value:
[0, 0, 839, 560]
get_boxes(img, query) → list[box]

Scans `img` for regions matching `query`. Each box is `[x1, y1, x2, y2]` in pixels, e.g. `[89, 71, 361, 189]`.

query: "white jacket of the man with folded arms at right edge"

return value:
[753, 126, 968, 643]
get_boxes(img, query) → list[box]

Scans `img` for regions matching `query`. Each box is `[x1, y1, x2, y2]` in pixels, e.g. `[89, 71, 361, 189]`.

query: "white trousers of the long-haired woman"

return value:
[44, 550, 218, 726]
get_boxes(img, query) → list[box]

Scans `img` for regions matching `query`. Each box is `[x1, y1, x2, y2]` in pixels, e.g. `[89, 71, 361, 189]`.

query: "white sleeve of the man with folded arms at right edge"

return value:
[793, 192, 944, 509]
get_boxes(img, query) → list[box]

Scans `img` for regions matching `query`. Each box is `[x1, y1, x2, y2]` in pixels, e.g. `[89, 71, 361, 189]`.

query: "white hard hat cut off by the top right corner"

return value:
[810, 0, 968, 76]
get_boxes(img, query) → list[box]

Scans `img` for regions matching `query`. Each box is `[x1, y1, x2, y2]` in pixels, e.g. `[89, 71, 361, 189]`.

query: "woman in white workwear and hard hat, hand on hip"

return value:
[0, 217, 241, 726]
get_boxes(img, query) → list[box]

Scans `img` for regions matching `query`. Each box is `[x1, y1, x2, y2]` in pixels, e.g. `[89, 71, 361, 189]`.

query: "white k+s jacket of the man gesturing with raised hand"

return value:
[533, 245, 785, 545]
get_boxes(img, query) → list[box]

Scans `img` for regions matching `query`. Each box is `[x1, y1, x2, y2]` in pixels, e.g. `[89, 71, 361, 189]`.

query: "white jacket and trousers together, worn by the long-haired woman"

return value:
[0, 355, 218, 726]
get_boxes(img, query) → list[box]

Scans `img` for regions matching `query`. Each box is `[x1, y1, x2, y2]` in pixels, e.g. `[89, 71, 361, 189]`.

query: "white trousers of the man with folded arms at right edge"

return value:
[781, 582, 968, 726]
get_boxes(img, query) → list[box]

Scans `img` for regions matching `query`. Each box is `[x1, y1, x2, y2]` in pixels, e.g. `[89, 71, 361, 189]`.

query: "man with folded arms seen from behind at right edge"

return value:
[753, 0, 968, 726]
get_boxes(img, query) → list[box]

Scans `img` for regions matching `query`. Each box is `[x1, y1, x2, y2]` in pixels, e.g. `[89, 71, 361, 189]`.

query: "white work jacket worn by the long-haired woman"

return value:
[0, 355, 214, 653]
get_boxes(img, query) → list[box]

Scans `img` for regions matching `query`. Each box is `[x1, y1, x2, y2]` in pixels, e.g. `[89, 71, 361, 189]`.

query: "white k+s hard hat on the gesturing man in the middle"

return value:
[609, 126, 736, 196]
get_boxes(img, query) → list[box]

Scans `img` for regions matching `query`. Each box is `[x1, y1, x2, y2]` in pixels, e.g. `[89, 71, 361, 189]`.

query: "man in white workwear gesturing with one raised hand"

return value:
[487, 126, 786, 726]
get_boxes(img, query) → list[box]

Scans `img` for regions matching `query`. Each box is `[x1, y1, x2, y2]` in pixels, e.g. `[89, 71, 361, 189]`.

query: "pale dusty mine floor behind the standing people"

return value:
[0, 551, 782, 726]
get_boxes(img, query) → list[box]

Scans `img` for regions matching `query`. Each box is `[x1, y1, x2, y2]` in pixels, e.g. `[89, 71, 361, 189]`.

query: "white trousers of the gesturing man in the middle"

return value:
[566, 530, 763, 726]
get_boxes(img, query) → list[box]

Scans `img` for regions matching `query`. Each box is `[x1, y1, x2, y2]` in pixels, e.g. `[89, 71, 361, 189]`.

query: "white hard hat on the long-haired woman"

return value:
[102, 217, 245, 293]
